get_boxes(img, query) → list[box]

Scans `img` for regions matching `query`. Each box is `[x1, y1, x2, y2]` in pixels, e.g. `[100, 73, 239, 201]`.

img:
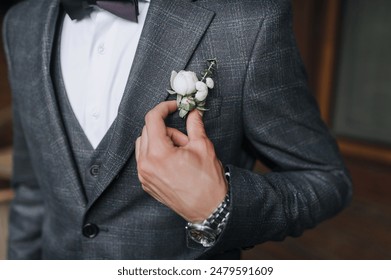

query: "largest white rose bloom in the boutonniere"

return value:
[171, 70, 198, 96]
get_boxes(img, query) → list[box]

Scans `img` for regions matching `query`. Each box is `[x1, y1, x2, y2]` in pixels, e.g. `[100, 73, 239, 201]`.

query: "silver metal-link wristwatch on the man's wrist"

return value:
[186, 174, 230, 247]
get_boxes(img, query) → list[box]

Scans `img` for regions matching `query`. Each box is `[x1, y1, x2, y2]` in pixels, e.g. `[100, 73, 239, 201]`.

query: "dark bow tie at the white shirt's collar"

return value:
[61, 0, 139, 22]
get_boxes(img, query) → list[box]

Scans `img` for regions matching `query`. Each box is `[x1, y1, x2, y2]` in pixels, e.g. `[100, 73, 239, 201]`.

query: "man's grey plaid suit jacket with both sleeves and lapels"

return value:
[3, 0, 351, 259]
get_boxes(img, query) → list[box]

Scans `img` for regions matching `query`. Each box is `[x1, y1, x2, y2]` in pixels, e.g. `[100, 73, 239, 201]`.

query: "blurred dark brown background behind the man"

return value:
[0, 0, 391, 260]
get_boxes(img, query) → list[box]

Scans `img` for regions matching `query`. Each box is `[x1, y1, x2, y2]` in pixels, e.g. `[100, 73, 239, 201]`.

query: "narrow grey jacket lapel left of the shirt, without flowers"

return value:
[40, 0, 87, 206]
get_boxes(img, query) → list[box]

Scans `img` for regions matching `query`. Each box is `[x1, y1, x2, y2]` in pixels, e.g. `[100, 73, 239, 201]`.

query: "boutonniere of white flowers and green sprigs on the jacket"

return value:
[167, 59, 217, 118]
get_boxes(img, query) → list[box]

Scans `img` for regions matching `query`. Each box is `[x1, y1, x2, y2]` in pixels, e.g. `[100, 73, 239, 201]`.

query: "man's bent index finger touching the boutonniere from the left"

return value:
[145, 100, 177, 139]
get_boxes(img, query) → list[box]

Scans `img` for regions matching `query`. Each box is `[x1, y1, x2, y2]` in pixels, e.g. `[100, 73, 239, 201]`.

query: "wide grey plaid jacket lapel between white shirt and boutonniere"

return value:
[89, 0, 214, 205]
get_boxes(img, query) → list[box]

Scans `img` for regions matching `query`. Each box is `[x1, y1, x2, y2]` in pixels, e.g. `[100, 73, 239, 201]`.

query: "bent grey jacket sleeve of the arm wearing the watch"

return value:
[210, 1, 351, 253]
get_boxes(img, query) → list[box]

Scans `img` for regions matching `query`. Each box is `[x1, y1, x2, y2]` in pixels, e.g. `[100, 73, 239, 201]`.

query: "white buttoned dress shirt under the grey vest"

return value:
[60, 2, 149, 149]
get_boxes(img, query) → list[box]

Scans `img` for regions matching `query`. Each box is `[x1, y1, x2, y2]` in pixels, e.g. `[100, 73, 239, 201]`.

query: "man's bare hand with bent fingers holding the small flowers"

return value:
[136, 101, 228, 222]
